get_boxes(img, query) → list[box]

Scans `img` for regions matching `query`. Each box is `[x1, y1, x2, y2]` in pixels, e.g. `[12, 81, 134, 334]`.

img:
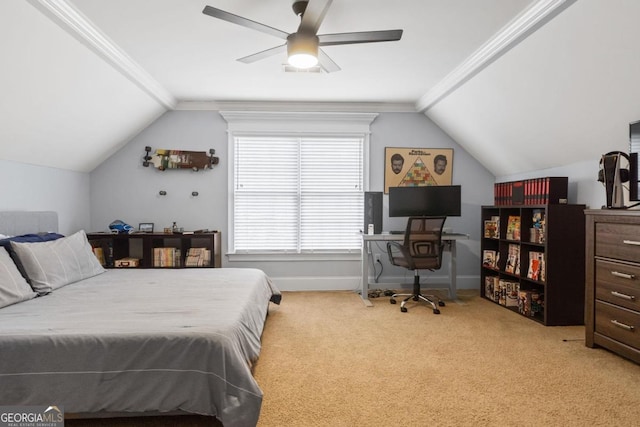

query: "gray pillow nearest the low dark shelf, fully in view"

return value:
[11, 230, 105, 295]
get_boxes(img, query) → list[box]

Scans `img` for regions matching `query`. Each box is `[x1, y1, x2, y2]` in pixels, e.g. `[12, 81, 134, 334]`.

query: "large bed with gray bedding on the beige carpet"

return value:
[0, 211, 281, 427]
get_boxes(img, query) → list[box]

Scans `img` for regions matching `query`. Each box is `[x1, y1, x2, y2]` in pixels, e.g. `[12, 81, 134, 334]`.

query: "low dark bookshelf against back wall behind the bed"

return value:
[87, 232, 222, 268]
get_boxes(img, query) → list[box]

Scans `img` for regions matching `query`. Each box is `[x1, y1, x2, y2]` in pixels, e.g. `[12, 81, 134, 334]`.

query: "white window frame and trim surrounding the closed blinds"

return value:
[220, 111, 378, 261]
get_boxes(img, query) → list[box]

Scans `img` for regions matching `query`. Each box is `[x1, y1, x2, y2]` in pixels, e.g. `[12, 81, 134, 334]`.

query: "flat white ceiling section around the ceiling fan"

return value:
[74, 0, 530, 102]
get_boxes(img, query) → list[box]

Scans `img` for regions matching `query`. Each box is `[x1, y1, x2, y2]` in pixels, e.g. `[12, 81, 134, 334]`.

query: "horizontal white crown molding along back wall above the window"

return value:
[175, 101, 417, 113]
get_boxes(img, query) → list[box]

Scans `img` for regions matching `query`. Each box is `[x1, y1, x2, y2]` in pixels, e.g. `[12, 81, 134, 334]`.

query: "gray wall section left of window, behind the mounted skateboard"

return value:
[91, 111, 228, 236]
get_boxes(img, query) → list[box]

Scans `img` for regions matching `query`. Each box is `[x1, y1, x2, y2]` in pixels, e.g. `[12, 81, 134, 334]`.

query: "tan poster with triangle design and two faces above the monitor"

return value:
[384, 147, 453, 194]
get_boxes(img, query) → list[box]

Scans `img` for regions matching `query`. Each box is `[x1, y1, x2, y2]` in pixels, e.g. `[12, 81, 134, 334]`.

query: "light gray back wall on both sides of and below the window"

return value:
[91, 111, 494, 290]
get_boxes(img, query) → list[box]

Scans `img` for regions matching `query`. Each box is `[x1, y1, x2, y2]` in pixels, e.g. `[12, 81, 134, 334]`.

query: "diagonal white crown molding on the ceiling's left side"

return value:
[27, 0, 178, 109]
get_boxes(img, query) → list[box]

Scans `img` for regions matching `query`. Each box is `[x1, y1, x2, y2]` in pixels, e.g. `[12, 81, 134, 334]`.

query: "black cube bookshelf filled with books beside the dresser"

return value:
[480, 204, 585, 326]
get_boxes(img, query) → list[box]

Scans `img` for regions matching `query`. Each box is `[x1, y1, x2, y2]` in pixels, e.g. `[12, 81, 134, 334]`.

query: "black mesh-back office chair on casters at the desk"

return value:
[387, 216, 447, 314]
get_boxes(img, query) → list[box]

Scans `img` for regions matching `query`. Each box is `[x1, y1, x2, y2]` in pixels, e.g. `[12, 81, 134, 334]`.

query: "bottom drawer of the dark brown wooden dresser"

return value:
[595, 301, 640, 348]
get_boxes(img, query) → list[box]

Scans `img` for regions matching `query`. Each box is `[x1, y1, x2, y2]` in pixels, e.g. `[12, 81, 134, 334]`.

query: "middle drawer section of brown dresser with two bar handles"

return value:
[595, 260, 640, 311]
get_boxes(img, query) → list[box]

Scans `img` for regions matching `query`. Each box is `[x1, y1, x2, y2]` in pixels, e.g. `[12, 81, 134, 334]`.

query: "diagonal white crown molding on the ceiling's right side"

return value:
[416, 0, 577, 113]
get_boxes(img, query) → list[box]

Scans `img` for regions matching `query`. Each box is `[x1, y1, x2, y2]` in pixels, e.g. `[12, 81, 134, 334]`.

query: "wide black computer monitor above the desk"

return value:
[389, 185, 462, 217]
